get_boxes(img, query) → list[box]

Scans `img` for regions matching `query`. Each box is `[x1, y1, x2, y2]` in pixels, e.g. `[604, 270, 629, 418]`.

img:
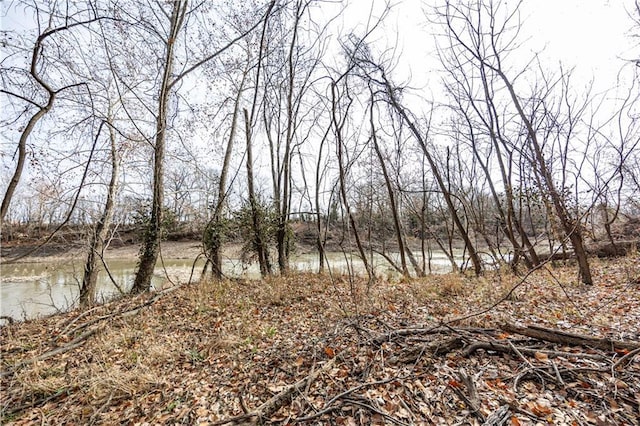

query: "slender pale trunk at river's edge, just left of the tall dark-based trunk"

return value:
[80, 123, 119, 308]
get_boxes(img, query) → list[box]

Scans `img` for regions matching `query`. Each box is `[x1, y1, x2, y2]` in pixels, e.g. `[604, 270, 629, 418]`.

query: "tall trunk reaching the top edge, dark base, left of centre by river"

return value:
[131, 0, 188, 294]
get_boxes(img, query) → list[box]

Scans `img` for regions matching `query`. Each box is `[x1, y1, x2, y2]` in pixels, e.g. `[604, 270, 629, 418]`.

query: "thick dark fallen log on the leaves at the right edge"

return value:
[500, 323, 640, 352]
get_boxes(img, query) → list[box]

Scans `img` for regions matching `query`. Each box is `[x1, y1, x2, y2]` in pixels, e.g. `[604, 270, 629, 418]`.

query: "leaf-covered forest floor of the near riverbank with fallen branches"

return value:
[0, 254, 640, 425]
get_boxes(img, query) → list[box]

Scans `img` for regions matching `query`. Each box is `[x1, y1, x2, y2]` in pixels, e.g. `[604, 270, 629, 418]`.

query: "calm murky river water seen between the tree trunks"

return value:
[0, 253, 450, 320]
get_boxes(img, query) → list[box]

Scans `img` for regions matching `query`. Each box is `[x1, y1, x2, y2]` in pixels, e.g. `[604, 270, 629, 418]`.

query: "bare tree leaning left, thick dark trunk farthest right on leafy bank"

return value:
[436, 0, 593, 284]
